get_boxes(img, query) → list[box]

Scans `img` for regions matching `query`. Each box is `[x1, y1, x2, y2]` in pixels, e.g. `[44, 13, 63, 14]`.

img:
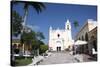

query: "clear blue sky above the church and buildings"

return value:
[13, 3, 97, 43]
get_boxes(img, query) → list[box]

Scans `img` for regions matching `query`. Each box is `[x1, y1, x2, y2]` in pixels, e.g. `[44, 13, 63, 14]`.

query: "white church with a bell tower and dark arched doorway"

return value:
[49, 20, 73, 51]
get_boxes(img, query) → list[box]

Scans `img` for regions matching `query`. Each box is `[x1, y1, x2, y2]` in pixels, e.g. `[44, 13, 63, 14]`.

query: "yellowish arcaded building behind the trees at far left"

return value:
[11, 39, 32, 55]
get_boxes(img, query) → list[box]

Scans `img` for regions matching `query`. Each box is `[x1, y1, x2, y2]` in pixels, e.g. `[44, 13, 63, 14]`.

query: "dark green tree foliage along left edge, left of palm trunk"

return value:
[11, 11, 22, 36]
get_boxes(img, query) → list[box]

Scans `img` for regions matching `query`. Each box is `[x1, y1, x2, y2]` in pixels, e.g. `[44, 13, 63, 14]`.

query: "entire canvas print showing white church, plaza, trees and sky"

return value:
[11, 2, 98, 66]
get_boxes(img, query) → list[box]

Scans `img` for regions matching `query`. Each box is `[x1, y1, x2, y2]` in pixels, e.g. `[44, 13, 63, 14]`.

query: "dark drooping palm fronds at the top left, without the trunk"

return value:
[12, 1, 46, 13]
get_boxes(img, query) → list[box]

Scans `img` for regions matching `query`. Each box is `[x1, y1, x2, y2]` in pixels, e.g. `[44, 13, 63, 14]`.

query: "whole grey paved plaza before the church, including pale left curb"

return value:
[28, 51, 94, 66]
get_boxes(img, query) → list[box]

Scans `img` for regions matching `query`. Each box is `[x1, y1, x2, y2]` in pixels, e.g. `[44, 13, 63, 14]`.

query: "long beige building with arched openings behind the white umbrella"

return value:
[75, 19, 97, 54]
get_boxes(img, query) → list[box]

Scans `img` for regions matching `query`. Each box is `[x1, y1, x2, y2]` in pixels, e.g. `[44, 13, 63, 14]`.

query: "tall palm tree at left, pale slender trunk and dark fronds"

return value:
[12, 1, 45, 53]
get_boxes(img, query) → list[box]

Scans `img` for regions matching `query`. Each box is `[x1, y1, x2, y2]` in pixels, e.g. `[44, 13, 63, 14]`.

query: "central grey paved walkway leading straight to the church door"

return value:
[39, 52, 77, 65]
